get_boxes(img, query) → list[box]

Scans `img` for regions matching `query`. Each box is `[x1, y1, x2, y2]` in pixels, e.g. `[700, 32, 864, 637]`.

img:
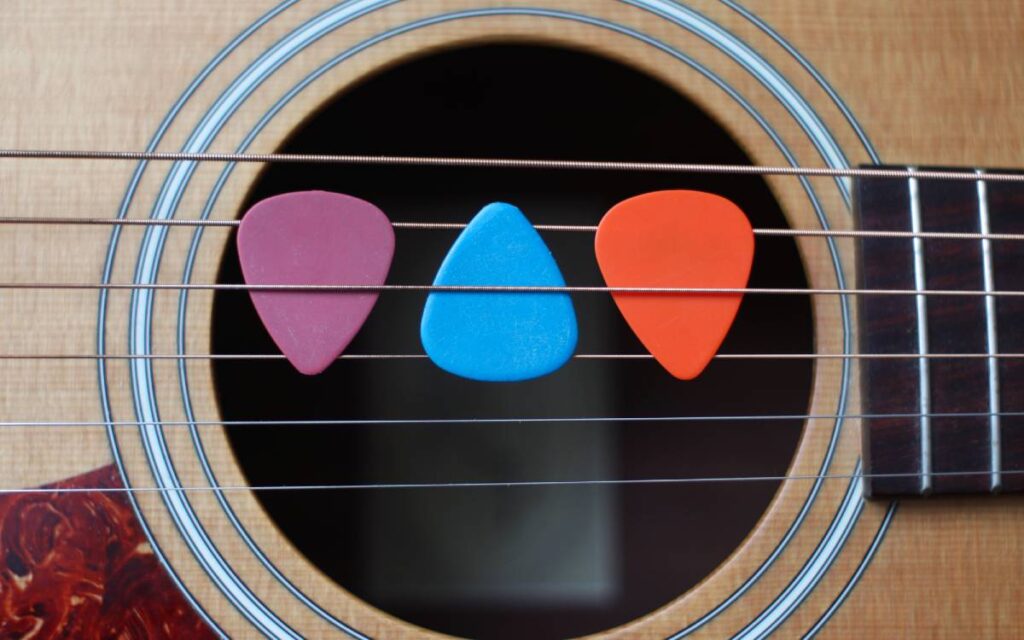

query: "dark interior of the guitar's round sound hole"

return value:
[212, 45, 812, 638]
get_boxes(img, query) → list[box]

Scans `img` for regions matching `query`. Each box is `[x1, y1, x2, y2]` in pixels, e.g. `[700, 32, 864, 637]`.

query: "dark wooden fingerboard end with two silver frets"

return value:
[854, 167, 1024, 497]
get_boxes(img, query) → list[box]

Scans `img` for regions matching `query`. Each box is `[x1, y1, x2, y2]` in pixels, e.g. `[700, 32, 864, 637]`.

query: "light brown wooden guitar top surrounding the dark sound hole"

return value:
[0, 0, 1024, 638]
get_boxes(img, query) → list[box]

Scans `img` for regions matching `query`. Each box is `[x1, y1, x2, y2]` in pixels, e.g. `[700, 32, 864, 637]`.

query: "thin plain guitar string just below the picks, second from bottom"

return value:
[6, 412, 1024, 429]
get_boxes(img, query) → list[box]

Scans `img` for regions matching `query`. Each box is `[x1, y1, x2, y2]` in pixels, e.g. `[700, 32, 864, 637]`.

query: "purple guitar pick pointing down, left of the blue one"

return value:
[238, 191, 394, 375]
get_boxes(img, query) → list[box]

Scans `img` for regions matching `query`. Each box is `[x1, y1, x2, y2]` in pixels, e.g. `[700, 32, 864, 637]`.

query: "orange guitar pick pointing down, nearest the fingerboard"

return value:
[594, 190, 754, 380]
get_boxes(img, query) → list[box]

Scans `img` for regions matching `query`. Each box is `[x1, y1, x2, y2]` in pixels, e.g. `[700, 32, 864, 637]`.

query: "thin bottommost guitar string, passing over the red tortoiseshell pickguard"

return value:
[0, 469, 1024, 495]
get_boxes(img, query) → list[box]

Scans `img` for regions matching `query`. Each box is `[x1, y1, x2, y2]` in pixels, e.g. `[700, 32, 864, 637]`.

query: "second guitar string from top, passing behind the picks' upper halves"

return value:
[0, 216, 1024, 242]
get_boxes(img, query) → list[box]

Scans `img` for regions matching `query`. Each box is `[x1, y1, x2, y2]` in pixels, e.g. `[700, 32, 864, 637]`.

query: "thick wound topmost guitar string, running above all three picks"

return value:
[0, 148, 1024, 182]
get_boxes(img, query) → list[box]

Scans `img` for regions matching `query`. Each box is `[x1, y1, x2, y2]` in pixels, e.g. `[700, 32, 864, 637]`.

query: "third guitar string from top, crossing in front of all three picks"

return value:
[0, 283, 1024, 298]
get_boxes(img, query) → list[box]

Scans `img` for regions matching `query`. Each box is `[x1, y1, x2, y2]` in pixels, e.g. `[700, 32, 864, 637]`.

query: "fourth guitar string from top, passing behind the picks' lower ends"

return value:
[9, 352, 1024, 360]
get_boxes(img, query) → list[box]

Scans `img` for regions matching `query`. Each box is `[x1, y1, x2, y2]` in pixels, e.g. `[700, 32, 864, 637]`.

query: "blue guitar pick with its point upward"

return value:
[420, 203, 577, 382]
